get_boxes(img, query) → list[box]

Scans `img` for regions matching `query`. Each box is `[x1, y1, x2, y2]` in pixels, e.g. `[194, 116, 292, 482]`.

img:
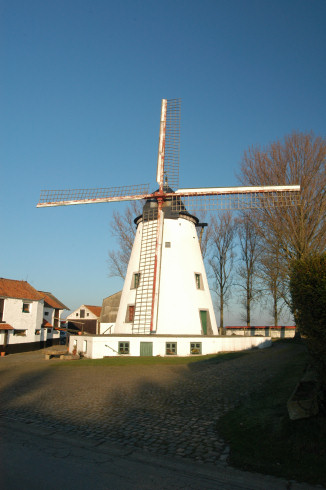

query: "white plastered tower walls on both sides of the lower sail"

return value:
[114, 217, 218, 335]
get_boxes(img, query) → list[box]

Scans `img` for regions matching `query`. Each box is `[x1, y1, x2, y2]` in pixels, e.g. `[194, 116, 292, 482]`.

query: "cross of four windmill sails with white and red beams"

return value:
[37, 99, 300, 333]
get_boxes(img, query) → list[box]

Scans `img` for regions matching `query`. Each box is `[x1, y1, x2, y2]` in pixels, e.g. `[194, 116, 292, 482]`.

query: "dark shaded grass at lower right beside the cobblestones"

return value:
[218, 345, 326, 485]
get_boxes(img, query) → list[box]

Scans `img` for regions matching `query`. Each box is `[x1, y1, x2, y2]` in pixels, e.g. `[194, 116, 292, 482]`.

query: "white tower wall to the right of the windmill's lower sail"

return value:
[156, 218, 218, 335]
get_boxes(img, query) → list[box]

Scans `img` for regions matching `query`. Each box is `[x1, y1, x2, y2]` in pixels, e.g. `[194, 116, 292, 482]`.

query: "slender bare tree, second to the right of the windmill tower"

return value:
[237, 214, 261, 327]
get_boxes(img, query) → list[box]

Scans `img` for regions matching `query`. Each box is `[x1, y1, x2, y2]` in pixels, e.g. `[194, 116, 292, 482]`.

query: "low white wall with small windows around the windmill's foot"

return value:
[69, 335, 272, 359]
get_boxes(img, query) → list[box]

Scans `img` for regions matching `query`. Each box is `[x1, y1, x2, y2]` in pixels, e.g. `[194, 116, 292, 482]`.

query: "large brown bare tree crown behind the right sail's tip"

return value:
[240, 132, 326, 262]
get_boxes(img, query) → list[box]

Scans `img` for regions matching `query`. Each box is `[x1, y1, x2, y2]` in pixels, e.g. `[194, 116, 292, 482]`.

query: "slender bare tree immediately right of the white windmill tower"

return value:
[208, 212, 235, 331]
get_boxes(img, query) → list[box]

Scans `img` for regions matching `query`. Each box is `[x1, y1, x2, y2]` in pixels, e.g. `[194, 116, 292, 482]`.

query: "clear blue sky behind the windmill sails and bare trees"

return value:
[0, 0, 326, 323]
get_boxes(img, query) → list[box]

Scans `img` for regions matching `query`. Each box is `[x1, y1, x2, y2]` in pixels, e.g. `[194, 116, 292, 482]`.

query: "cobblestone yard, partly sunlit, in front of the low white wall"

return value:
[0, 344, 298, 464]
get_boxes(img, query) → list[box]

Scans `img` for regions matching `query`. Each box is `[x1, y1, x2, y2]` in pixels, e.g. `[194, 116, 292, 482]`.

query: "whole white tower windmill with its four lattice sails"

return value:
[37, 99, 300, 335]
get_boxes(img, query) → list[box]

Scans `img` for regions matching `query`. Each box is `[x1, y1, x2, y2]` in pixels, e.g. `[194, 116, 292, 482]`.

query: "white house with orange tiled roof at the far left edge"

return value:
[0, 278, 67, 355]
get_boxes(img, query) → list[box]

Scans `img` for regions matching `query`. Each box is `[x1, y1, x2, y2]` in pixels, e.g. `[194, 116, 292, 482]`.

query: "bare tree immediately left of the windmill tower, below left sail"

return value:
[108, 201, 143, 279]
